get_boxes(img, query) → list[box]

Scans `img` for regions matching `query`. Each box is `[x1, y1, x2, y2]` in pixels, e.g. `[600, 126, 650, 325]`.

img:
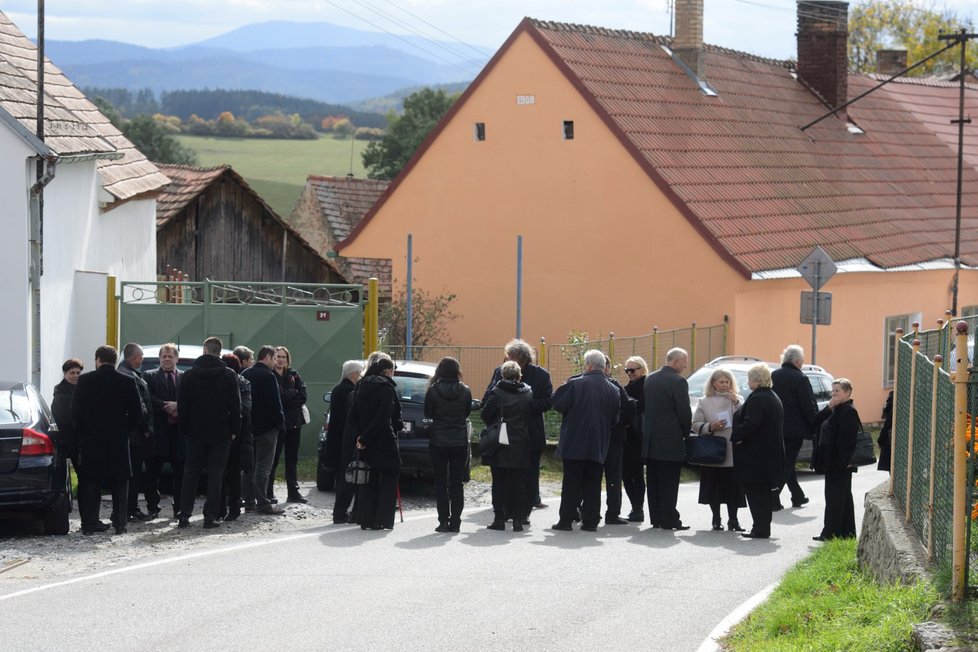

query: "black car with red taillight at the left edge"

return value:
[0, 381, 72, 534]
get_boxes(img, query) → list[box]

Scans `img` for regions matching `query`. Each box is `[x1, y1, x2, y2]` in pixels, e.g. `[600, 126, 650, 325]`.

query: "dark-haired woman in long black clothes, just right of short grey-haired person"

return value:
[346, 355, 404, 530]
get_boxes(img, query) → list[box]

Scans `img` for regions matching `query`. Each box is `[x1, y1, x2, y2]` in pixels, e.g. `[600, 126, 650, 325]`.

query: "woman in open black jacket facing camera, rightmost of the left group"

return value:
[268, 346, 309, 503]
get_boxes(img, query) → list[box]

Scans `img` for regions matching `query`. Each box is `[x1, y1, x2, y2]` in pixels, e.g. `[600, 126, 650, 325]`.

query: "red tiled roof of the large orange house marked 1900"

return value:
[338, 19, 978, 276]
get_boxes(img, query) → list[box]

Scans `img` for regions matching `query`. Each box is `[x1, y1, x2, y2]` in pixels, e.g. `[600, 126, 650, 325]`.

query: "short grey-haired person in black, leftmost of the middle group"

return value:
[324, 360, 363, 523]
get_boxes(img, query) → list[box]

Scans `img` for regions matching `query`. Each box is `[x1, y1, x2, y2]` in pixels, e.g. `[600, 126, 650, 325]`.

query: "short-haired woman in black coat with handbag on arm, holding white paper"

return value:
[482, 360, 533, 532]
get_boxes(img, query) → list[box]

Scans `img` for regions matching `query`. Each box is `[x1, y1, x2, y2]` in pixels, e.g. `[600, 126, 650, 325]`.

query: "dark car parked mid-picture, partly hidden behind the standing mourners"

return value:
[316, 361, 482, 491]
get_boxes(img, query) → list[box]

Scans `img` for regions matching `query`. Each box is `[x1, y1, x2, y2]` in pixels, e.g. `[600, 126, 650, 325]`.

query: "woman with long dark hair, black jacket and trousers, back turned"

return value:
[424, 358, 472, 532]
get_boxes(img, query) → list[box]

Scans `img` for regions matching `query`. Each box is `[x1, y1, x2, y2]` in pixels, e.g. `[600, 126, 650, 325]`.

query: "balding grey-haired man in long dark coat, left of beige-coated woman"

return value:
[642, 348, 693, 530]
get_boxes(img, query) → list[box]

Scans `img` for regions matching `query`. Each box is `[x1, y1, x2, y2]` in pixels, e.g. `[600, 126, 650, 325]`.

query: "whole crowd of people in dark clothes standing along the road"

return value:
[52, 338, 864, 541]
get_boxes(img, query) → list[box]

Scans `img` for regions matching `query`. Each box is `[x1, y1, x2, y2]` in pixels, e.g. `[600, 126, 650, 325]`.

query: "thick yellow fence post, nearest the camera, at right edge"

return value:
[951, 321, 970, 602]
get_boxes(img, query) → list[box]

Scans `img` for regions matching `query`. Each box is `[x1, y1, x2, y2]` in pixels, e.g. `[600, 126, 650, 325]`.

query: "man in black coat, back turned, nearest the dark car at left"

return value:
[71, 345, 143, 535]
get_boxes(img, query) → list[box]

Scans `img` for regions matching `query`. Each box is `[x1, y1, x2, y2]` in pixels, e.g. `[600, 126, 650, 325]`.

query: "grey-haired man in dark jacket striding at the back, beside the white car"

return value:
[771, 344, 818, 512]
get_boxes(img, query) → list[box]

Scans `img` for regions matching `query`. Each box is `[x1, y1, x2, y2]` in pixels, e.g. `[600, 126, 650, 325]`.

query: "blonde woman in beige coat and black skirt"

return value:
[693, 369, 747, 532]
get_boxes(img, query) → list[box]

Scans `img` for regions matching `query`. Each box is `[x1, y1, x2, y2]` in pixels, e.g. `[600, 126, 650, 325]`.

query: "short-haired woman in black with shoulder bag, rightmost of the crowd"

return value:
[812, 378, 862, 541]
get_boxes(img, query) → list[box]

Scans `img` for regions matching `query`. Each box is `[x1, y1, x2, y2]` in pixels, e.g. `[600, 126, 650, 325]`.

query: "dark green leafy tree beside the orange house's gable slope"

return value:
[363, 88, 458, 179]
